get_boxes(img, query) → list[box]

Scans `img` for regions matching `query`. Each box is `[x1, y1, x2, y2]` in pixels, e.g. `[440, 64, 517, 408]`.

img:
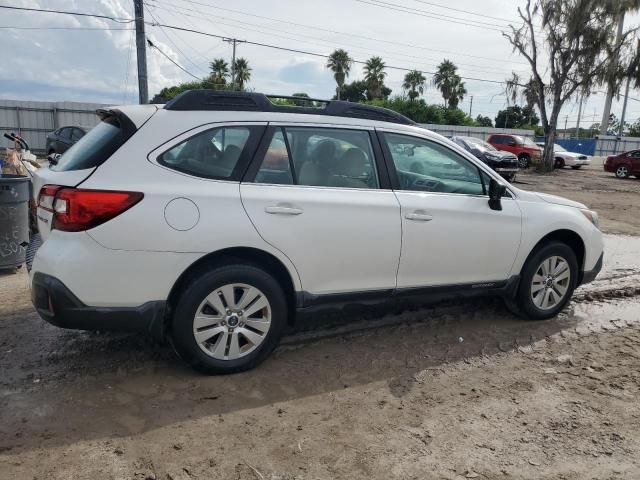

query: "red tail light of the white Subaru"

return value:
[38, 185, 144, 232]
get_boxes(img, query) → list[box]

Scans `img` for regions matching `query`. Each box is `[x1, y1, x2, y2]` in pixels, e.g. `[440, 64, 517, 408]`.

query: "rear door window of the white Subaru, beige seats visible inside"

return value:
[255, 127, 379, 188]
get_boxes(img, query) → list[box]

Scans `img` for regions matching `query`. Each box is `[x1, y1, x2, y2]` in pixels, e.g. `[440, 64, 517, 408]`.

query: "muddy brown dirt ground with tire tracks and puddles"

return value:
[0, 169, 640, 480]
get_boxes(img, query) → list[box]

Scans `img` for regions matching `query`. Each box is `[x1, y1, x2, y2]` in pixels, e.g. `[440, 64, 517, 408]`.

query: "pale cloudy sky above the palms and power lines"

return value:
[0, 0, 640, 128]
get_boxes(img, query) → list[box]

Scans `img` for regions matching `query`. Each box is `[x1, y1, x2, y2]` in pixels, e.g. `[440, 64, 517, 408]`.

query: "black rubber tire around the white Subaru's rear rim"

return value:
[171, 264, 288, 374]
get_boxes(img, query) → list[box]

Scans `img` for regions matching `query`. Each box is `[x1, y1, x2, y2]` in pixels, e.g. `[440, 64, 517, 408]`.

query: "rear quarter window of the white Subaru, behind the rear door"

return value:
[158, 127, 251, 179]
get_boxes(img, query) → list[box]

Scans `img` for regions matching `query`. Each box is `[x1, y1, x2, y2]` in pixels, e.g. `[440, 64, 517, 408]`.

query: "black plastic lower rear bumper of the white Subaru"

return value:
[31, 272, 166, 338]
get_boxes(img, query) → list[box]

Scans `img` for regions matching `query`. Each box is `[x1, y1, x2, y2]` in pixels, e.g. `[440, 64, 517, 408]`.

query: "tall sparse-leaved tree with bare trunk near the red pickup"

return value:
[503, 0, 630, 171]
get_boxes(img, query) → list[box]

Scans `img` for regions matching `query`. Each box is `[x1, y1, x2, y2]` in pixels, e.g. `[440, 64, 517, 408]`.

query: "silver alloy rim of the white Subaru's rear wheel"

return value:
[193, 283, 271, 360]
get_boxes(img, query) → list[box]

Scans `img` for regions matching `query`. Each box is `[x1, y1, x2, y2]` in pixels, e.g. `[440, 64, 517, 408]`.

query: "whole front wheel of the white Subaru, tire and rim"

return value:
[515, 242, 578, 320]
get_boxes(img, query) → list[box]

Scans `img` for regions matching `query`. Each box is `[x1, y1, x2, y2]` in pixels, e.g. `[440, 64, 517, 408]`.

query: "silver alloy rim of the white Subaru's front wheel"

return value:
[531, 256, 571, 310]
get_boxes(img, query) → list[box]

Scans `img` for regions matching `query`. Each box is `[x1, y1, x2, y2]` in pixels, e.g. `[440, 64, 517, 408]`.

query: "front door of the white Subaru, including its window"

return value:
[380, 131, 521, 289]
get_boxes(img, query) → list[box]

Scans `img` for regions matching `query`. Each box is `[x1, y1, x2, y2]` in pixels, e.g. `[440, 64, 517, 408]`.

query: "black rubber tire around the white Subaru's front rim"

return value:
[510, 242, 578, 320]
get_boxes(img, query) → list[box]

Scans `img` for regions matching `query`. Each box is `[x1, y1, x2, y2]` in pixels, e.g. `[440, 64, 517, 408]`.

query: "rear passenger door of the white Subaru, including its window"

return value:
[240, 124, 401, 301]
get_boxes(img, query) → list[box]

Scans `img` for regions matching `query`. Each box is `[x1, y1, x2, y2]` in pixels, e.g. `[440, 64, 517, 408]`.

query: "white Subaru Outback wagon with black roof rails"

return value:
[31, 90, 603, 373]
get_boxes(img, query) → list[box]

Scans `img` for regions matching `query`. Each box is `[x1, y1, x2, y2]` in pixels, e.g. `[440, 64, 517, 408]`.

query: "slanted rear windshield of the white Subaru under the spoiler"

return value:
[51, 116, 130, 172]
